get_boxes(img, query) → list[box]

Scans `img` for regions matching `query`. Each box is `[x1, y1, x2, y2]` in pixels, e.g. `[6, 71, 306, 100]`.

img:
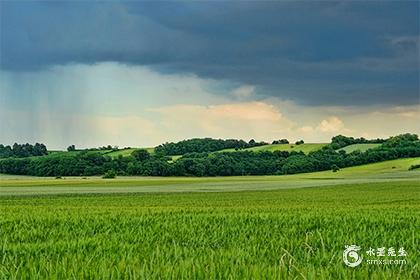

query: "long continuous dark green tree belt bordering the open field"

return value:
[0, 134, 420, 176]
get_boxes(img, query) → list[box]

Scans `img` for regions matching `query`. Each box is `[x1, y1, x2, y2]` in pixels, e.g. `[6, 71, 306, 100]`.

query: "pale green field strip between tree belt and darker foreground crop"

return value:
[0, 158, 420, 196]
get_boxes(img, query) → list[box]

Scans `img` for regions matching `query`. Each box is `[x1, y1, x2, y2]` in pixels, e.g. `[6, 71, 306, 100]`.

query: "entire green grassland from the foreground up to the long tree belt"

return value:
[0, 158, 420, 279]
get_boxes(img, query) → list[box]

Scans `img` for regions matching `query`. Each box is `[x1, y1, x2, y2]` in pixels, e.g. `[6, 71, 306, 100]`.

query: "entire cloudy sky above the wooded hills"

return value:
[0, 1, 420, 149]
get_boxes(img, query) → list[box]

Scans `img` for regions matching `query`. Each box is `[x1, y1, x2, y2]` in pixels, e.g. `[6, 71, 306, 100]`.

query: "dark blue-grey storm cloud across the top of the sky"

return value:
[0, 1, 419, 105]
